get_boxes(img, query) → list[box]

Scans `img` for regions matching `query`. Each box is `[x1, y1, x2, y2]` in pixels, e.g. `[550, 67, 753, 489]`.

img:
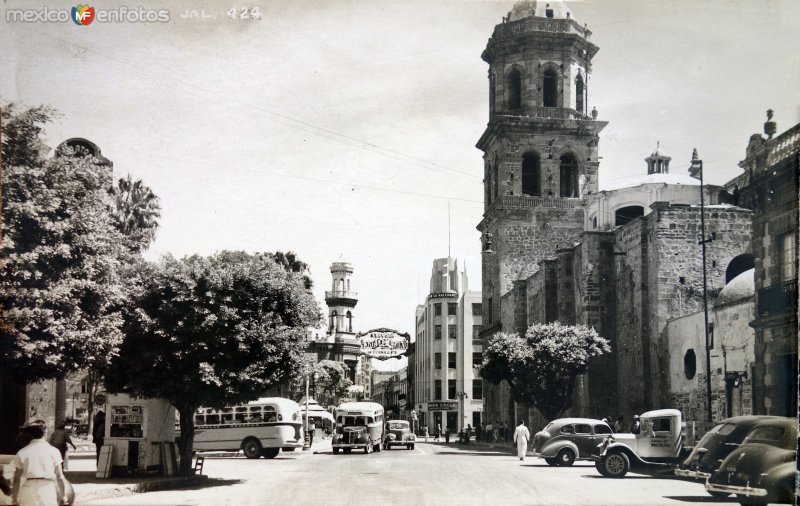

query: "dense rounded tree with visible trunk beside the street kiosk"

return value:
[106, 251, 320, 473]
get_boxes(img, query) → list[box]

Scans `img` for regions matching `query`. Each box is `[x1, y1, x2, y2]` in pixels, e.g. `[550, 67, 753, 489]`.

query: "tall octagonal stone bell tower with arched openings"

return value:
[477, 2, 606, 336]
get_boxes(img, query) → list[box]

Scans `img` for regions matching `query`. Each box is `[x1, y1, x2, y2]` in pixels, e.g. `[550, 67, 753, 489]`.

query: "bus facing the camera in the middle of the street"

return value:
[332, 402, 385, 455]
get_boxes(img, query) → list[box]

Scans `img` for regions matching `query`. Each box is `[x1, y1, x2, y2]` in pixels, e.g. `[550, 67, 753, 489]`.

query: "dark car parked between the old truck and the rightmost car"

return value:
[675, 416, 780, 486]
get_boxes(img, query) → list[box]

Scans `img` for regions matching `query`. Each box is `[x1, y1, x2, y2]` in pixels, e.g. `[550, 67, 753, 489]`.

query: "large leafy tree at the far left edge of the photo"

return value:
[0, 108, 126, 381]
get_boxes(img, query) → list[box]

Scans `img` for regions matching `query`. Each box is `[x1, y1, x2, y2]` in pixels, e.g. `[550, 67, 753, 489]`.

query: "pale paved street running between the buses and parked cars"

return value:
[79, 443, 748, 506]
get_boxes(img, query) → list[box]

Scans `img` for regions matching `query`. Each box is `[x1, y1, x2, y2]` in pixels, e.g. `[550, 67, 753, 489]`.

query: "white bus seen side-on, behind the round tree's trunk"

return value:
[193, 397, 303, 459]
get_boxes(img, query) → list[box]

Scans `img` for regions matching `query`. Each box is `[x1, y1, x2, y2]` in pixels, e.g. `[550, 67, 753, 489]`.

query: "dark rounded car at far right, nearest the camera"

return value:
[706, 417, 797, 505]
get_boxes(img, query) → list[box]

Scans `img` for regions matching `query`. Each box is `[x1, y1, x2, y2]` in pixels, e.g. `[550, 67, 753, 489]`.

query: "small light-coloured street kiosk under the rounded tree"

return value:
[98, 394, 176, 475]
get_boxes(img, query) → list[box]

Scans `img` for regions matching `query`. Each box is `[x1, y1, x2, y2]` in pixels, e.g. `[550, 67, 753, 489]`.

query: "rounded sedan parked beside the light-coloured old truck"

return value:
[533, 418, 614, 466]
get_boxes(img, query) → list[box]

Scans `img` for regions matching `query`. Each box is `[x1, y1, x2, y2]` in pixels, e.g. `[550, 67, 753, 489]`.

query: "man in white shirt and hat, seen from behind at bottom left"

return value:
[11, 420, 70, 506]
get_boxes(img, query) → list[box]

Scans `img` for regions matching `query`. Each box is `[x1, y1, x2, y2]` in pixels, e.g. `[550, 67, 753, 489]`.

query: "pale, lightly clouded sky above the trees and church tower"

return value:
[0, 0, 800, 369]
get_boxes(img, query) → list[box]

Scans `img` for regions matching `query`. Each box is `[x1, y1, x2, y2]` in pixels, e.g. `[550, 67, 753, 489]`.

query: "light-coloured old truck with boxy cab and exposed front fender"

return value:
[593, 409, 689, 478]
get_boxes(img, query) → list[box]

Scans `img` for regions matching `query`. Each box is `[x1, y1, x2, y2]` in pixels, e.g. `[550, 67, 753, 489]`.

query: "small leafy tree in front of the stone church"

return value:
[481, 322, 611, 420]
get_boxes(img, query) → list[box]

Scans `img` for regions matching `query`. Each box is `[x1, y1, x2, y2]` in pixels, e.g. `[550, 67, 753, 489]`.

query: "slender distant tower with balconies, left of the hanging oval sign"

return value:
[325, 262, 361, 382]
